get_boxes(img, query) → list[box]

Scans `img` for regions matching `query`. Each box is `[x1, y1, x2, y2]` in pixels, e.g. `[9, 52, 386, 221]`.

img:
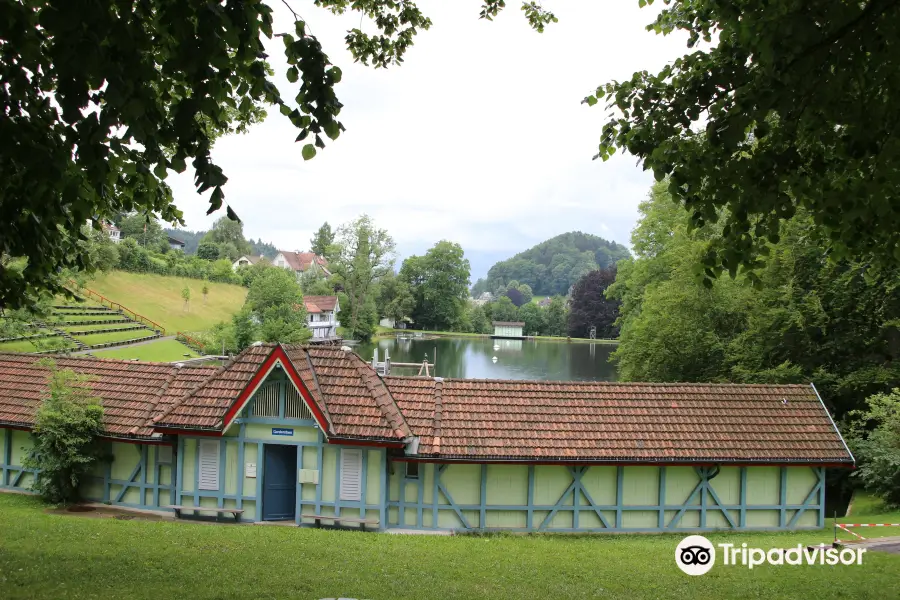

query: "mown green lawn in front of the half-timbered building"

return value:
[0, 494, 900, 600]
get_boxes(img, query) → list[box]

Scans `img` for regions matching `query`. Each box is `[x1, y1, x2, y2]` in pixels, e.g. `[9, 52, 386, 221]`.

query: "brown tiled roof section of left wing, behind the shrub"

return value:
[0, 352, 214, 438]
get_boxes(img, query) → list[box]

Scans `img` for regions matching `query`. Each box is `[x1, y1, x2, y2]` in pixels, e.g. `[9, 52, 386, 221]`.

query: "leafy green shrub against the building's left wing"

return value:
[24, 360, 107, 504]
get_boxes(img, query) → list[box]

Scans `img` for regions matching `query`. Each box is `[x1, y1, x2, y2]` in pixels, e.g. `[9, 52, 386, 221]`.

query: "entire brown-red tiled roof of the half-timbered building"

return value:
[0, 344, 853, 464]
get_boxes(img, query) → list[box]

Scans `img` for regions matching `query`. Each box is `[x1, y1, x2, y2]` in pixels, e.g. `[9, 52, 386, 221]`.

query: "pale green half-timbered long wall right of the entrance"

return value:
[388, 462, 824, 531]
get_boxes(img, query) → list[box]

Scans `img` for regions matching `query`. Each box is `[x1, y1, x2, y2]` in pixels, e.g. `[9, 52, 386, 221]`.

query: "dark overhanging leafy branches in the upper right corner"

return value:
[596, 0, 900, 282]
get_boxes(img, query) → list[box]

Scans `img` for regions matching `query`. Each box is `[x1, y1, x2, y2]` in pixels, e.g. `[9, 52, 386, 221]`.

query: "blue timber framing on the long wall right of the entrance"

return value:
[387, 463, 825, 533]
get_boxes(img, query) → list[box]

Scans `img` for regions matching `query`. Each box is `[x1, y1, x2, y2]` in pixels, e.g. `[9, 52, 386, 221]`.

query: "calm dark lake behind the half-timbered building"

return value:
[353, 337, 616, 381]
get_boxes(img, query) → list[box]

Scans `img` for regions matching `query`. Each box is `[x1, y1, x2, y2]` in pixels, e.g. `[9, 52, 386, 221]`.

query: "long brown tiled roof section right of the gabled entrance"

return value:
[385, 377, 853, 465]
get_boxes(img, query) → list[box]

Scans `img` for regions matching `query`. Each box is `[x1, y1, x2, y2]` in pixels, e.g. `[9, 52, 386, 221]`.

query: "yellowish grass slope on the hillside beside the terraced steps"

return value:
[86, 271, 247, 335]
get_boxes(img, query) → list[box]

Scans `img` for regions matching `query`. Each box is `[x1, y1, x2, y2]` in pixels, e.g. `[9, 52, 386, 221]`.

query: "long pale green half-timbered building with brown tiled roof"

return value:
[0, 344, 854, 532]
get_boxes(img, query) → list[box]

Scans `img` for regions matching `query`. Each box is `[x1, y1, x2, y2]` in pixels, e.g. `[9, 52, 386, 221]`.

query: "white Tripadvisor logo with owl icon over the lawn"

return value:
[675, 535, 866, 575]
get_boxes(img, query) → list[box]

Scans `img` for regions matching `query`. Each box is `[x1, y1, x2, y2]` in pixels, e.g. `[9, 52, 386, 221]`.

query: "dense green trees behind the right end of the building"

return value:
[608, 182, 900, 506]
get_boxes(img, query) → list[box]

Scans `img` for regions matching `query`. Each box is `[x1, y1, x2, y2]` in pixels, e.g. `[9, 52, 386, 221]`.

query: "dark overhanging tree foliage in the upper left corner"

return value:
[0, 0, 568, 308]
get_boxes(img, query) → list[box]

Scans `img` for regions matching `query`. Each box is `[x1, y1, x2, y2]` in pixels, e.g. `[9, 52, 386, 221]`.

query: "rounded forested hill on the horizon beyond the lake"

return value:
[472, 231, 630, 296]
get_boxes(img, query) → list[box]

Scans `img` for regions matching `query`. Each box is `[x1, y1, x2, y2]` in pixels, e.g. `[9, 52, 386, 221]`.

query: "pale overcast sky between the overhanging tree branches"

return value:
[168, 0, 686, 283]
